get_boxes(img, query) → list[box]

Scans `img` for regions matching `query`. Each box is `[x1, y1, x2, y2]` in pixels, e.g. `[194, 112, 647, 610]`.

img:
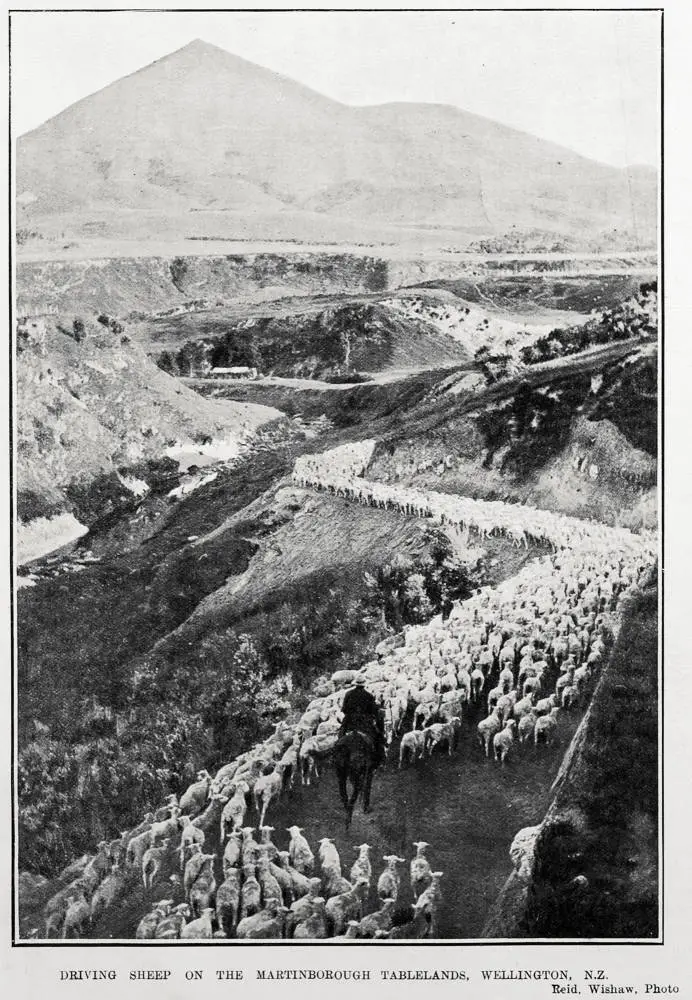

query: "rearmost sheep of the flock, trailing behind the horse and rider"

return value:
[45, 788, 442, 941]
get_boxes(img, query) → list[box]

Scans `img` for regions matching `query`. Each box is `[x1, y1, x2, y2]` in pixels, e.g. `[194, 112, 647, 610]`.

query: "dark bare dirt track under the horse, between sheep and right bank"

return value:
[86, 715, 578, 944]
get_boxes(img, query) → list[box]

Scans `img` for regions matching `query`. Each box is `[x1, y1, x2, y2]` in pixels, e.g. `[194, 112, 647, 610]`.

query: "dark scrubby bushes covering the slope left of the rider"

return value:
[18, 532, 482, 874]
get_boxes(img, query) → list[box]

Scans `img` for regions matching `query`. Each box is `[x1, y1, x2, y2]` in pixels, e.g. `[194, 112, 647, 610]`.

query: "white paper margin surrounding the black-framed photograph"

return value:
[0, 0, 692, 998]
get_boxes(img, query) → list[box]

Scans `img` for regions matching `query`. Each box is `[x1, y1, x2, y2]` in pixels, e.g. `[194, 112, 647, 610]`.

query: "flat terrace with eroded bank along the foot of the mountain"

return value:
[17, 249, 656, 317]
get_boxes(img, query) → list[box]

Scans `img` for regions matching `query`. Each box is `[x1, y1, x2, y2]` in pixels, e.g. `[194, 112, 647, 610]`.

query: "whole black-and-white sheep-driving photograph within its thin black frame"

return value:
[7, 9, 660, 944]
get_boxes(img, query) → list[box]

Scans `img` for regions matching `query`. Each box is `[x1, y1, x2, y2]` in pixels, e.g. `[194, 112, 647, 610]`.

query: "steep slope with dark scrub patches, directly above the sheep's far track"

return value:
[368, 347, 656, 526]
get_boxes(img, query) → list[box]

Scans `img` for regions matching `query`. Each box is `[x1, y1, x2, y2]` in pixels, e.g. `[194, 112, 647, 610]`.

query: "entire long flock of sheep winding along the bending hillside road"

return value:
[33, 442, 655, 940]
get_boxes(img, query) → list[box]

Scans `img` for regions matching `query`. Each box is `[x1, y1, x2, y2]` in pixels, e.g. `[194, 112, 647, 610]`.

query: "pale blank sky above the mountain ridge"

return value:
[11, 11, 660, 166]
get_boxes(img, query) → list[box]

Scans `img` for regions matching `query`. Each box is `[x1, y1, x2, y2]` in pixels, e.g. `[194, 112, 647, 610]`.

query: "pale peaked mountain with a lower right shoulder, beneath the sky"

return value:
[17, 40, 657, 250]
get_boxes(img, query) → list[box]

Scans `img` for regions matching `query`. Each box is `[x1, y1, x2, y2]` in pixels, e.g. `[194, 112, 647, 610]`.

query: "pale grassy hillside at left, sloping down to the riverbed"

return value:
[15, 317, 279, 523]
